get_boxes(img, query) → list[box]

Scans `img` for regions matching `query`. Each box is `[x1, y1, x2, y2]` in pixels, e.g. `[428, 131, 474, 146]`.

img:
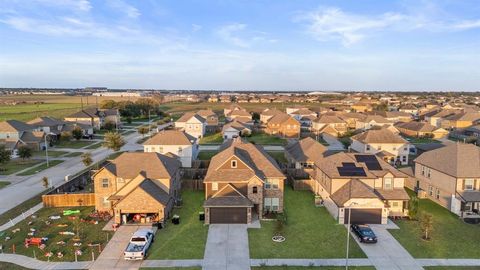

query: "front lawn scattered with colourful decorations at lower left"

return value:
[0, 207, 113, 261]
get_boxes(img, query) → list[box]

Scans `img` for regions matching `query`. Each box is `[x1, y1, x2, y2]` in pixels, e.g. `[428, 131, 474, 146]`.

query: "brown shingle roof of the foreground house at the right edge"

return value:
[414, 143, 480, 177]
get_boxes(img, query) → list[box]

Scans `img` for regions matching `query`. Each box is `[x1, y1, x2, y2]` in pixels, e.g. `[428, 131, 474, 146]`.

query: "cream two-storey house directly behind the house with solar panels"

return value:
[350, 128, 410, 165]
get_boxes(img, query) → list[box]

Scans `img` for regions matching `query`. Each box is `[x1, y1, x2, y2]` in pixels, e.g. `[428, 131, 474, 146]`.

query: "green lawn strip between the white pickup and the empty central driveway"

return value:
[148, 191, 208, 260]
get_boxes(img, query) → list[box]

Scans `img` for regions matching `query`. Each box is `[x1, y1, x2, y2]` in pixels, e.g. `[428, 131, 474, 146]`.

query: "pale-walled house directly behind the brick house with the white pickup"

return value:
[143, 130, 199, 168]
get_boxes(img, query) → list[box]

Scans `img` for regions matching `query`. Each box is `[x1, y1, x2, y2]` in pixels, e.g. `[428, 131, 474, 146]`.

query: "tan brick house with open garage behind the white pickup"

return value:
[92, 152, 181, 224]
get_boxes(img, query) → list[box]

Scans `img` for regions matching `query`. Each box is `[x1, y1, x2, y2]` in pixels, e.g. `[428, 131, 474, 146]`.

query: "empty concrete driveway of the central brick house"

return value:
[203, 224, 250, 270]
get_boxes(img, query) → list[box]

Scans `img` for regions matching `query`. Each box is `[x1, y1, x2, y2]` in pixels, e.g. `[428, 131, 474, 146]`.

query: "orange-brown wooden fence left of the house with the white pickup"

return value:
[42, 193, 95, 207]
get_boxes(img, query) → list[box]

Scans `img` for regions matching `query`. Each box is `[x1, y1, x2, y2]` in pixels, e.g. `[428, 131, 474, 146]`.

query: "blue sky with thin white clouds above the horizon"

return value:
[0, 0, 480, 91]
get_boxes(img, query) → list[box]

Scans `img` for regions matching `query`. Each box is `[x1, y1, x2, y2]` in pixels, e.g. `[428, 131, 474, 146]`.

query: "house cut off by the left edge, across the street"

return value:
[0, 120, 45, 152]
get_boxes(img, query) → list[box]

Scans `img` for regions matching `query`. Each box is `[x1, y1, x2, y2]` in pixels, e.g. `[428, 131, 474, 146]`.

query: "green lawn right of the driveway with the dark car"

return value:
[390, 188, 480, 258]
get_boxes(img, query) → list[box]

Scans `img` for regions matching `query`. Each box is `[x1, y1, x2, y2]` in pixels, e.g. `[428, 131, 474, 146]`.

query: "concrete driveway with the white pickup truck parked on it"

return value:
[89, 226, 142, 269]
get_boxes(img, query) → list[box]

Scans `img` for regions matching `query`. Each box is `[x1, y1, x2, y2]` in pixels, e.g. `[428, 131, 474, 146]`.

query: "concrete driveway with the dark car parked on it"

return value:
[352, 222, 423, 270]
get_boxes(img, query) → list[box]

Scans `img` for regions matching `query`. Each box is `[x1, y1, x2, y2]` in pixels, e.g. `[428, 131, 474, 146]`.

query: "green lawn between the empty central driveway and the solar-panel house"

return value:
[248, 187, 365, 259]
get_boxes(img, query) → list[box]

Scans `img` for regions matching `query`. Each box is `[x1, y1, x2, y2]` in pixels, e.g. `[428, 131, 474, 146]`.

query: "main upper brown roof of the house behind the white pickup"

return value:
[102, 152, 181, 179]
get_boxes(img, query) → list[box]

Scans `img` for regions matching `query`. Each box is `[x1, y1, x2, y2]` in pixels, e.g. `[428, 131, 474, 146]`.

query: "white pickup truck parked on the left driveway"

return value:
[123, 229, 155, 260]
